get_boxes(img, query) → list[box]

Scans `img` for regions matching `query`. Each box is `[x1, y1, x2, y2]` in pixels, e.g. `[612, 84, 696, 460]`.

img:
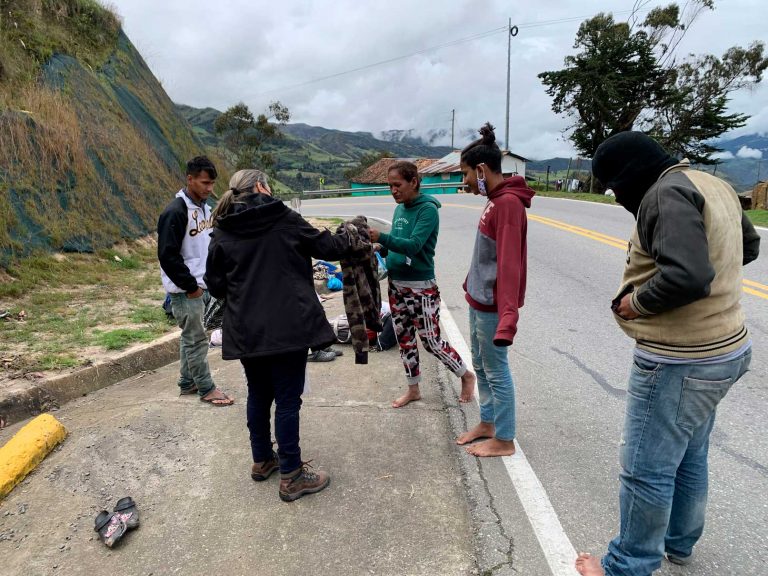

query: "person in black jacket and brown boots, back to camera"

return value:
[205, 170, 349, 501]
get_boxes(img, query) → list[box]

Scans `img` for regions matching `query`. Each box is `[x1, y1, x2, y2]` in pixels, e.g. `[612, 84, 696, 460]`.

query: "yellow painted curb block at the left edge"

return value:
[0, 414, 67, 500]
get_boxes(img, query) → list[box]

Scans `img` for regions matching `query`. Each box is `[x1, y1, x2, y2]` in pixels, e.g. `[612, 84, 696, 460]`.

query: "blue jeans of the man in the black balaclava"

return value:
[602, 350, 752, 576]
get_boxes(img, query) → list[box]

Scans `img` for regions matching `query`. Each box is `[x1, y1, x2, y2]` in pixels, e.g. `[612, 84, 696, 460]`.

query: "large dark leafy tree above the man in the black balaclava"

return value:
[539, 0, 768, 163]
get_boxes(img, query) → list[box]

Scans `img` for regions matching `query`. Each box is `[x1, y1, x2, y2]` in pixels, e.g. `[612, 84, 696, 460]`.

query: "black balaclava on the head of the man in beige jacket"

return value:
[592, 132, 678, 216]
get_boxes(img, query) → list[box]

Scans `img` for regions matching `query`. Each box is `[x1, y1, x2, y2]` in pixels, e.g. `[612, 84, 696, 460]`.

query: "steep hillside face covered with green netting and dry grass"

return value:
[0, 24, 213, 265]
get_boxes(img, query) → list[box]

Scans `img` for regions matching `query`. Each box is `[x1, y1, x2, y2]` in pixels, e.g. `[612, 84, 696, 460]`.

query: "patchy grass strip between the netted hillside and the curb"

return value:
[0, 218, 340, 380]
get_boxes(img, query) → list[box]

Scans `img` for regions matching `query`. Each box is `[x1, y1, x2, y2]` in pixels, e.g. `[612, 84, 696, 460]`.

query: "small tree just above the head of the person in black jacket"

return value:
[214, 102, 291, 172]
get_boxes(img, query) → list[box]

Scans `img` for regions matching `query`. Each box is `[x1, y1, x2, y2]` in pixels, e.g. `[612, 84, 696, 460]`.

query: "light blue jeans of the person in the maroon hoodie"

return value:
[469, 308, 515, 441]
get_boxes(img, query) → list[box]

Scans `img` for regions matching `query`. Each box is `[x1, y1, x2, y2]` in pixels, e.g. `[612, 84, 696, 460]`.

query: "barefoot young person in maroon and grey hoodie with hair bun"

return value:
[456, 124, 534, 456]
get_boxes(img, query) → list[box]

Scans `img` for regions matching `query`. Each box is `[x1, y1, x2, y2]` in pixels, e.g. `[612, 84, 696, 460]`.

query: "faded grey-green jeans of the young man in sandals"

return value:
[171, 290, 215, 397]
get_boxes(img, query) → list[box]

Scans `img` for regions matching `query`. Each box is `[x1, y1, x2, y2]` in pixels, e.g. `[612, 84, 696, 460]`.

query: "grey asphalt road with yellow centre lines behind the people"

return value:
[302, 195, 768, 576]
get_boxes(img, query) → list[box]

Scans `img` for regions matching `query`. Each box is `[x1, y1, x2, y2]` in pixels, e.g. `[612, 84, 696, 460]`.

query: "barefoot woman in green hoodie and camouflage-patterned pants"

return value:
[371, 161, 475, 408]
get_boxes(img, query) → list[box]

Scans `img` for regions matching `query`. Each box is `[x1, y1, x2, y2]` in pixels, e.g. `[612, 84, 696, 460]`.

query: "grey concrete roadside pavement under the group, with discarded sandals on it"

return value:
[0, 295, 477, 575]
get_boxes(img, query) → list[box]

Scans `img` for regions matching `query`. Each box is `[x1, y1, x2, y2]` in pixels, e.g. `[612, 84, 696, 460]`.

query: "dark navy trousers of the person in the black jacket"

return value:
[240, 349, 307, 474]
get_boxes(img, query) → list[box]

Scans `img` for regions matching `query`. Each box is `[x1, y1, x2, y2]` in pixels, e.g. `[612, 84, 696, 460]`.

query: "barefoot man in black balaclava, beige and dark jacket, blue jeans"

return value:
[576, 132, 760, 576]
